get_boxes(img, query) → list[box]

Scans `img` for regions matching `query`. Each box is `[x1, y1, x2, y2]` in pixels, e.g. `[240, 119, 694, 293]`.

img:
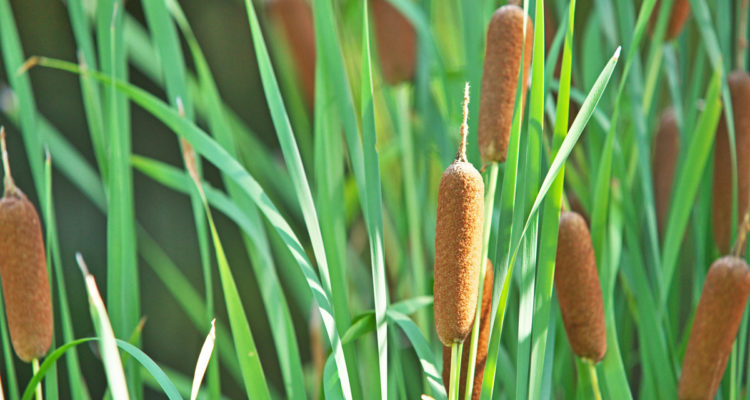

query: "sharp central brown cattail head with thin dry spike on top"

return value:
[433, 84, 484, 346]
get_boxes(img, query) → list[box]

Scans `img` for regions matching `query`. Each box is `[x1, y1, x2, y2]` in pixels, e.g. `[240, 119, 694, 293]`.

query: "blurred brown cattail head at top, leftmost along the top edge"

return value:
[267, 0, 316, 105]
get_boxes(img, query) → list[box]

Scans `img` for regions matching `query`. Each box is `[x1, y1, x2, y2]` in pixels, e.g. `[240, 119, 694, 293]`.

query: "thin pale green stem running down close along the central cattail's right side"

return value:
[464, 162, 500, 399]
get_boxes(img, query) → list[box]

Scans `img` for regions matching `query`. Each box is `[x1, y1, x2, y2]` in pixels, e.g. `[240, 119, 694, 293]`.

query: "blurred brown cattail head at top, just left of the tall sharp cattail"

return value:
[372, 0, 417, 85]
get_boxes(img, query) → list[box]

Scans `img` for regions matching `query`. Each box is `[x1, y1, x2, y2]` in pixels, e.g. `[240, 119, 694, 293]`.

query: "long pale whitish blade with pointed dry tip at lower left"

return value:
[75, 253, 130, 400]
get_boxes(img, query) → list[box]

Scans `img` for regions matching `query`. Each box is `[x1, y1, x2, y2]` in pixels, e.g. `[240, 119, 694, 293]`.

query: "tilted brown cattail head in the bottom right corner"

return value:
[677, 256, 750, 400]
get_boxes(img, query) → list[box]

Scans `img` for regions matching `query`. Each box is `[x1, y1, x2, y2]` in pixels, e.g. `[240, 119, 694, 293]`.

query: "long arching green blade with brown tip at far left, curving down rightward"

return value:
[29, 58, 346, 400]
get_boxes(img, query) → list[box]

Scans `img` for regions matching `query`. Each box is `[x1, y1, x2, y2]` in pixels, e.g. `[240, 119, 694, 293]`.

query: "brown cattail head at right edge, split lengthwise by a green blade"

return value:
[713, 71, 750, 254]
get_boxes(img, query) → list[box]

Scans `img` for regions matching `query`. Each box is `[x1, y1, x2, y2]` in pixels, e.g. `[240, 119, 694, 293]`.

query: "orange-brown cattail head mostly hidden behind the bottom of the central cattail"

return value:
[443, 259, 494, 400]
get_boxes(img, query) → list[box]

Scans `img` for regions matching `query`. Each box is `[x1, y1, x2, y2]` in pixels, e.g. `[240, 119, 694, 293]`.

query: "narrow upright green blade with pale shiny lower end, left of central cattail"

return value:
[360, 1, 388, 399]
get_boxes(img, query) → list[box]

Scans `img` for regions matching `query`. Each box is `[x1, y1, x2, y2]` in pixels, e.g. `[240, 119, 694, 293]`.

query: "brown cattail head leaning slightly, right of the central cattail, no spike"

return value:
[555, 211, 607, 362]
